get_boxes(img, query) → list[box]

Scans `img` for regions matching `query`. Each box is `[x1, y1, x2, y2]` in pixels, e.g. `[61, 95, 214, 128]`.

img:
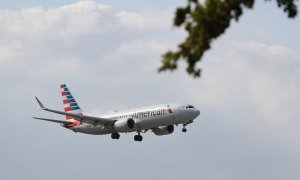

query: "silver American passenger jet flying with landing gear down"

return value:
[33, 84, 200, 141]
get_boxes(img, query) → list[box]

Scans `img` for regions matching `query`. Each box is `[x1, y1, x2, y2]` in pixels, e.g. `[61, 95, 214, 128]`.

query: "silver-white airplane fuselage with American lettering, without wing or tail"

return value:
[69, 103, 200, 134]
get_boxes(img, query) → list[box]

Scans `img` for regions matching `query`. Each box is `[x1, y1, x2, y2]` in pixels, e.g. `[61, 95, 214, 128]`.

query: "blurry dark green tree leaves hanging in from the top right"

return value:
[159, 0, 297, 77]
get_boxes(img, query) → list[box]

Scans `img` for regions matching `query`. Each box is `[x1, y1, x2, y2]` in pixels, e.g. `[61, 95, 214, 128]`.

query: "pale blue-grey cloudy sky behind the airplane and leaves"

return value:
[0, 0, 300, 180]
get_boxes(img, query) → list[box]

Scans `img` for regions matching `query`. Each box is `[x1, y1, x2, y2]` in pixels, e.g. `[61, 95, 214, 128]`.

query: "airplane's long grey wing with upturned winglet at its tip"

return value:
[35, 97, 115, 126]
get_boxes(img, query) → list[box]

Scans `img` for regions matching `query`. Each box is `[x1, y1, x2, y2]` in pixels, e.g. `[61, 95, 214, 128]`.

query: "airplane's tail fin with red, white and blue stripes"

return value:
[60, 84, 82, 120]
